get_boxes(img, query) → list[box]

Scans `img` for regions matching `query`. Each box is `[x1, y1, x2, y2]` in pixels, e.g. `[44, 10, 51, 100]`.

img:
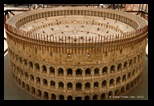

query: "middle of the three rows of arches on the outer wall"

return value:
[11, 60, 139, 90]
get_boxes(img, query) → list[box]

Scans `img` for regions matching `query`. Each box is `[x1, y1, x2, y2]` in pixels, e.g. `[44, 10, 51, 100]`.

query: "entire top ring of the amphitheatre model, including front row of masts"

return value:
[5, 7, 148, 47]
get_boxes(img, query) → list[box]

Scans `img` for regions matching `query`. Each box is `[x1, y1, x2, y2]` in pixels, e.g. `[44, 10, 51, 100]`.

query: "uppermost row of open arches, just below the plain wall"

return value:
[10, 48, 142, 77]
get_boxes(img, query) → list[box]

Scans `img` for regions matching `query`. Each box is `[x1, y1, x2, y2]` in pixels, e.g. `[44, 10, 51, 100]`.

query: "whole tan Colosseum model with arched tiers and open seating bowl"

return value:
[5, 7, 148, 100]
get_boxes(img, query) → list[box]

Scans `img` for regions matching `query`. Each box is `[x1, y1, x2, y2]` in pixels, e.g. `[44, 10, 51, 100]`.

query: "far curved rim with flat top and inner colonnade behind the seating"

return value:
[7, 7, 148, 29]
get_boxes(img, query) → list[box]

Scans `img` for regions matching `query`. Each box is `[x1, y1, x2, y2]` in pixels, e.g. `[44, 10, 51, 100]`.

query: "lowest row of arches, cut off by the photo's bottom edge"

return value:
[13, 71, 140, 100]
